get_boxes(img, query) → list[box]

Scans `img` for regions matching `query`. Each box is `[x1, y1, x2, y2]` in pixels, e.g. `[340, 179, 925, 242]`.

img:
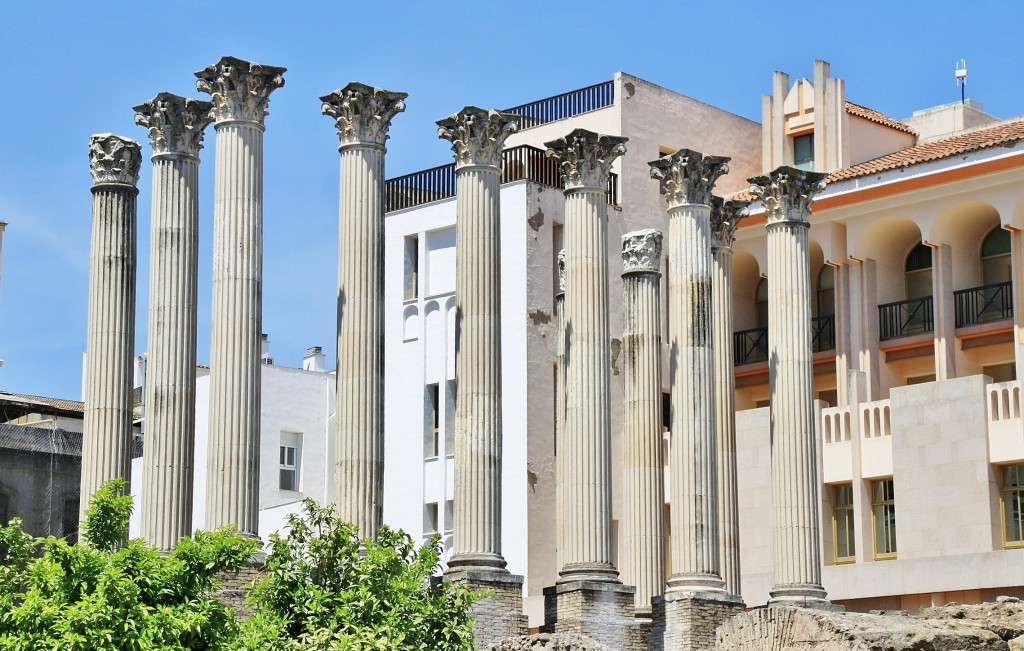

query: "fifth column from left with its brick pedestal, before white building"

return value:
[437, 106, 526, 645]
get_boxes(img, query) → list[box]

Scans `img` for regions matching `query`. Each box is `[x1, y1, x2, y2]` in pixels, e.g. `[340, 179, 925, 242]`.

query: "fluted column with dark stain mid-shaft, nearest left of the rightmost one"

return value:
[650, 149, 729, 598]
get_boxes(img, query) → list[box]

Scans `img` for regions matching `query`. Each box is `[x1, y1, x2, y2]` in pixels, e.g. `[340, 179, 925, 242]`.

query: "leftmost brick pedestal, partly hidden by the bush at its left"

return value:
[444, 564, 528, 648]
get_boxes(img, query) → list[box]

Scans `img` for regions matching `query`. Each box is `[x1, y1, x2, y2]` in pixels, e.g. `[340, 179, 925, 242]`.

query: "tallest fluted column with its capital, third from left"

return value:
[196, 56, 285, 535]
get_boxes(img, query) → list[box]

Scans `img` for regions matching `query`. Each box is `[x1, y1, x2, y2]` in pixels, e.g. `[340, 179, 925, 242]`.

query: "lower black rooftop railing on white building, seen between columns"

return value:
[384, 144, 618, 212]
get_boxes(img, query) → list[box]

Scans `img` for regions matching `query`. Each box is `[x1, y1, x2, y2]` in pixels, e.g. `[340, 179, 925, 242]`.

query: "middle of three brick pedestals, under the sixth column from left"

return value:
[541, 581, 647, 651]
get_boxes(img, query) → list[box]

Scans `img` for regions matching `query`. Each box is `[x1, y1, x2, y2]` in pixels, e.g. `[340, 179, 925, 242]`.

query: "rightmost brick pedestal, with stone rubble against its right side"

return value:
[648, 591, 746, 651]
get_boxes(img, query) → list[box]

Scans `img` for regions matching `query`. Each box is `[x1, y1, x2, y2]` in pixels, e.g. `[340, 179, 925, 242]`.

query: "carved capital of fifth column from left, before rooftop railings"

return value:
[437, 106, 519, 167]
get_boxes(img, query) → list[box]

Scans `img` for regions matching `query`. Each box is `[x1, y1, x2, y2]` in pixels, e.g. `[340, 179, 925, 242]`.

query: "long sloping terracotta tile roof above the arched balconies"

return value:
[828, 120, 1024, 183]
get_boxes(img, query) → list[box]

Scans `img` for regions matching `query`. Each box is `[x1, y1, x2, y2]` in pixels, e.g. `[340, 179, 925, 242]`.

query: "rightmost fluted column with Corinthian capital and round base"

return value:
[751, 166, 827, 607]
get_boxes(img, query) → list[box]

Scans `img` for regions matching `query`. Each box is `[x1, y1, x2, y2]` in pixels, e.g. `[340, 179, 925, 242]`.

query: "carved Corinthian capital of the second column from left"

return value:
[132, 92, 213, 158]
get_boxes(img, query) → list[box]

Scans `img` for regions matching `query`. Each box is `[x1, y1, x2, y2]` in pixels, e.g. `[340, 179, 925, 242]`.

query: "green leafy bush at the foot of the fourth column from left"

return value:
[238, 500, 480, 651]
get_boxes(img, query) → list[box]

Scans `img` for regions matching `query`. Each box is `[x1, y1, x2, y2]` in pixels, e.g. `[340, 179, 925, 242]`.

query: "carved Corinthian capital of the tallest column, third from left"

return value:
[196, 56, 287, 124]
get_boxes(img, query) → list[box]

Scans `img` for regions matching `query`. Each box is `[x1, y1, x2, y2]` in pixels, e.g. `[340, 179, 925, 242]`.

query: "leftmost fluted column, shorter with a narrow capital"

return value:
[80, 133, 142, 515]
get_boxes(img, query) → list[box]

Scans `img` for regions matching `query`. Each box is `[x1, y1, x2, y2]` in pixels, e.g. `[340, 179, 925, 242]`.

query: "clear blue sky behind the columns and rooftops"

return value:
[0, 0, 1024, 398]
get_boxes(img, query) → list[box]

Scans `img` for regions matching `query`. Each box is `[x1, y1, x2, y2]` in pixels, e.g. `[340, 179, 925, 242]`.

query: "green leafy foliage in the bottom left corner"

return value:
[0, 480, 257, 651]
